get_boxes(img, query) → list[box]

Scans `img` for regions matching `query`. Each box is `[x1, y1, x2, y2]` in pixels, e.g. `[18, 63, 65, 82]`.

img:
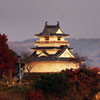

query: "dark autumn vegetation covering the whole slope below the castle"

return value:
[0, 67, 100, 100]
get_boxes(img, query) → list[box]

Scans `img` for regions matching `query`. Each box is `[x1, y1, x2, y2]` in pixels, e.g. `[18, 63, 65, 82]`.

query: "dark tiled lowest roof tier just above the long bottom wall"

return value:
[31, 47, 85, 62]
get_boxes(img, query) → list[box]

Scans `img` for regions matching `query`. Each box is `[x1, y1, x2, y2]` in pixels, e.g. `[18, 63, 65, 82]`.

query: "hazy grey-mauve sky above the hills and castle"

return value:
[0, 0, 100, 41]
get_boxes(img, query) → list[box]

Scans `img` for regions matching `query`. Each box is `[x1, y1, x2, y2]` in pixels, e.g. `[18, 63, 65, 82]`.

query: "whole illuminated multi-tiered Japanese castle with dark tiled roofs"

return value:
[25, 22, 81, 73]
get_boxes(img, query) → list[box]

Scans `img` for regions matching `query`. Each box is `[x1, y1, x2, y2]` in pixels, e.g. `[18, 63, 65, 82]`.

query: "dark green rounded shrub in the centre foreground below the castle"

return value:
[35, 74, 68, 96]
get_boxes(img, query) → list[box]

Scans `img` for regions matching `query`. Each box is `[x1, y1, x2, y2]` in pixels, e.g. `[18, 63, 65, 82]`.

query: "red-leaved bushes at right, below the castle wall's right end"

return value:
[66, 67, 100, 90]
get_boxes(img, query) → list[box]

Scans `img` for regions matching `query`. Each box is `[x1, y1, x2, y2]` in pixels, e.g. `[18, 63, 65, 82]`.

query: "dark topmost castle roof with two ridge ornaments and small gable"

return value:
[35, 22, 69, 37]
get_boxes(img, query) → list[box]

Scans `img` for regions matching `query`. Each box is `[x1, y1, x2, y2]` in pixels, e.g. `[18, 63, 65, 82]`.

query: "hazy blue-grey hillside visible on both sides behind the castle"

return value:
[8, 38, 100, 67]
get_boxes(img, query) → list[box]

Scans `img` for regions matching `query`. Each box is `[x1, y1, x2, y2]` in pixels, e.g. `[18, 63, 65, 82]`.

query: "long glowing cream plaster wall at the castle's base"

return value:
[25, 61, 79, 73]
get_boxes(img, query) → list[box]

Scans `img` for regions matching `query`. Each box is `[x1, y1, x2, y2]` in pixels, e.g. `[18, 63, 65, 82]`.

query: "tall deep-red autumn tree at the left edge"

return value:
[0, 33, 17, 76]
